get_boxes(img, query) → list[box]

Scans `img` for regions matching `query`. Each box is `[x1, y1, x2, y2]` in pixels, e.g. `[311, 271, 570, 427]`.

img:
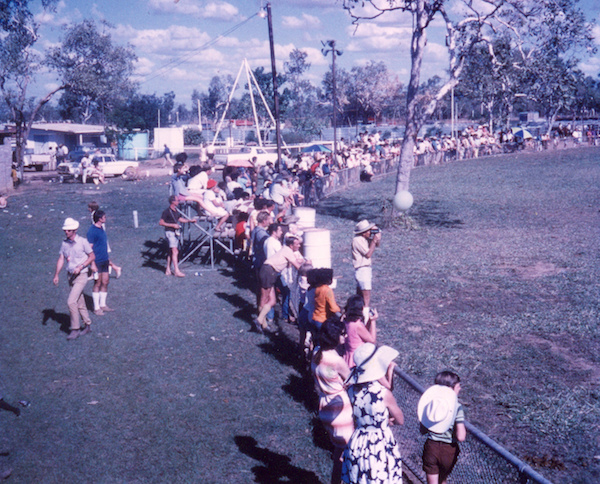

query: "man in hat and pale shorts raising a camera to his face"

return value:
[352, 219, 381, 315]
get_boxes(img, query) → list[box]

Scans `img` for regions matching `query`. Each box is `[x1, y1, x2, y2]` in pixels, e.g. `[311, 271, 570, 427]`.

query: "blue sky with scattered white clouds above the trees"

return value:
[33, 0, 600, 104]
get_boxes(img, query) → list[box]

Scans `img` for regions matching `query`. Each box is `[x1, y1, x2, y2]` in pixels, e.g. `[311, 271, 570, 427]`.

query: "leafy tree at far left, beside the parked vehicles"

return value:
[0, 0, 135, 167]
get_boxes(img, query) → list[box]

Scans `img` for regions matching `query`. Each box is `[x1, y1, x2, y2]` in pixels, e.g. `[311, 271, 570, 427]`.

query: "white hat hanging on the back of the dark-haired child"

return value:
[417, 385, 458, 434]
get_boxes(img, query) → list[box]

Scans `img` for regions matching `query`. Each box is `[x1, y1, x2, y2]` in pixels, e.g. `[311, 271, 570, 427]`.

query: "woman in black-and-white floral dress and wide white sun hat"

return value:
[342, 343, 404, 484]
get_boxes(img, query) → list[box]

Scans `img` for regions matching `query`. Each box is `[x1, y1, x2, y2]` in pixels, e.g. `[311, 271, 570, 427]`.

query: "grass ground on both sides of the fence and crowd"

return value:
[0, 149, 600, 483]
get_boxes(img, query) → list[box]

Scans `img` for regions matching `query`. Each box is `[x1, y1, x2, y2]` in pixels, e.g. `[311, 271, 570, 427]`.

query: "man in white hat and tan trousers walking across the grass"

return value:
[53, 217, 94, 340]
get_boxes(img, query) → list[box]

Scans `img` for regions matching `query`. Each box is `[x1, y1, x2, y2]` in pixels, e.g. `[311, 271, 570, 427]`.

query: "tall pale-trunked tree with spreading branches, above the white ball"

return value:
[343, 0, 591, 192]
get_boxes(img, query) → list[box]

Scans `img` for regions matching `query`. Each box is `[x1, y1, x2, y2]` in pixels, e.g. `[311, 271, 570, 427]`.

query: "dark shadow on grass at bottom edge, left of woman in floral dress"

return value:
[234, 435, 321, 484]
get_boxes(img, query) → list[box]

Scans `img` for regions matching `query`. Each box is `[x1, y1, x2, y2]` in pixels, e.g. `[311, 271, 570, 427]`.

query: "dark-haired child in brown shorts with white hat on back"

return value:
[418, 371, 467, 484]
